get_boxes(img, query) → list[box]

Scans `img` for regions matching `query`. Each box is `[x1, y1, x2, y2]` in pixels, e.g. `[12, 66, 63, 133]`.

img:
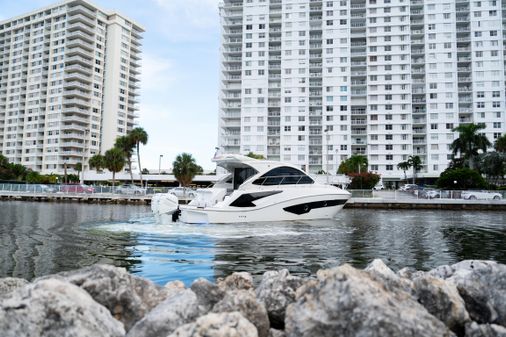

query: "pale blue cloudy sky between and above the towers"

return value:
[0, 0, 220, 169]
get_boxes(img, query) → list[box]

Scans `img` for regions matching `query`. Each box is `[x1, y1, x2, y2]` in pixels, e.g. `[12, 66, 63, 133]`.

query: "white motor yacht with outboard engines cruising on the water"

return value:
[151, 154, 351, 223]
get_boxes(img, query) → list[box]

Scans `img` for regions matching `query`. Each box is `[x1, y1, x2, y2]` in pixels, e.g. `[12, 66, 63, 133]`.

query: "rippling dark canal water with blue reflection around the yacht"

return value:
[0, 201, 506, 284]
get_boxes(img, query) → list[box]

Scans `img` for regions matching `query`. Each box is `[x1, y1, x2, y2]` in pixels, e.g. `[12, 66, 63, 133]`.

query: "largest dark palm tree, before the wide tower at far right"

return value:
[450, 123, 491, 169]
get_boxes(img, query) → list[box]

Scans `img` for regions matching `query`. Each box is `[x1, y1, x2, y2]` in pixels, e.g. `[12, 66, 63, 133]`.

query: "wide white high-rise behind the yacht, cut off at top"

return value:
[219, 0, 506, 180]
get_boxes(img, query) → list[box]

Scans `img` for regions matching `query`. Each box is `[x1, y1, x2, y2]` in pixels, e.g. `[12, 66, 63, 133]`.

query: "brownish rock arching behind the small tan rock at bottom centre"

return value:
[213, 290, 270, 337]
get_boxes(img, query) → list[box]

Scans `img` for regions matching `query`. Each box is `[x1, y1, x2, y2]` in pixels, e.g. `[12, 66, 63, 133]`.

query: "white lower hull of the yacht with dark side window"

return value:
[180, 195, 349, 223]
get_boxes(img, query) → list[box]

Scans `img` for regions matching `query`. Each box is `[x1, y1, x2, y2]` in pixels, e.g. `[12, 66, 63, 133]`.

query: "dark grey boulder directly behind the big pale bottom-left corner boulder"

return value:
[41, 265, 169, 331]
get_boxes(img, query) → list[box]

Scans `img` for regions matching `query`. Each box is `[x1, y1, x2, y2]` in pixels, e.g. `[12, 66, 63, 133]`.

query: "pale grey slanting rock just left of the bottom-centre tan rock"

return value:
[127, 289, 199, 337]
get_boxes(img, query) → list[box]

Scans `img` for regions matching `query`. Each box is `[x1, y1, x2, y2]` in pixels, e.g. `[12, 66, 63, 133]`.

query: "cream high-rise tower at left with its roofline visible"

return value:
[0, 0, 144, 173]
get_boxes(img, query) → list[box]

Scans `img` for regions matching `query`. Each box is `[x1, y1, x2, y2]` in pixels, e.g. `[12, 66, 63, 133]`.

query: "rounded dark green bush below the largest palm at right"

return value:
[436, 167, 487, 190]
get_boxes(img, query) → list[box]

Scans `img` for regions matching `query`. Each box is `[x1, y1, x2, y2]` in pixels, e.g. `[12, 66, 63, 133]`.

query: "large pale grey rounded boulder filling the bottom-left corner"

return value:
[0, 279, 125, 337]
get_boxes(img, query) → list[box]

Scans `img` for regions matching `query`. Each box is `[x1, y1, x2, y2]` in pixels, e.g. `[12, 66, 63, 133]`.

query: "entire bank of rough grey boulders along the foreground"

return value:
[0, 260, 506, 337]
